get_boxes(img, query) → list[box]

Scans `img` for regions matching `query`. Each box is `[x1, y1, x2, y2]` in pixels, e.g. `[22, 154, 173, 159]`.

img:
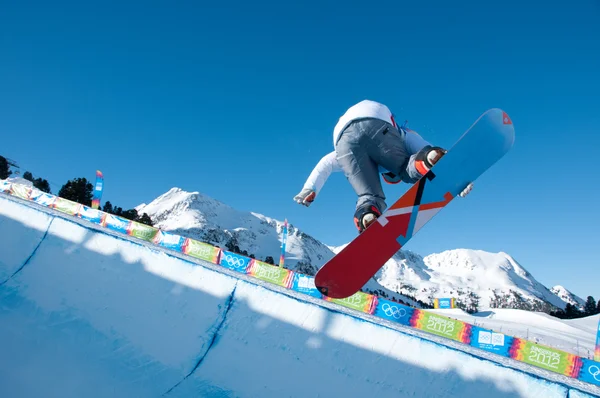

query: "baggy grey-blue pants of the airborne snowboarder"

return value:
[335, 118, 430, 213]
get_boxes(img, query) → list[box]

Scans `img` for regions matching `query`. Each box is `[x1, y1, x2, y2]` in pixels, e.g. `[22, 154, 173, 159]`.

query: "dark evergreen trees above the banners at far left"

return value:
[0, 155, 153, 226]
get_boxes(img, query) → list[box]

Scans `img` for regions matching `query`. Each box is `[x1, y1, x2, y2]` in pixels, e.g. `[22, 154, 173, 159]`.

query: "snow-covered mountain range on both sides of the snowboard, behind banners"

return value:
[136, 188, 580, 311]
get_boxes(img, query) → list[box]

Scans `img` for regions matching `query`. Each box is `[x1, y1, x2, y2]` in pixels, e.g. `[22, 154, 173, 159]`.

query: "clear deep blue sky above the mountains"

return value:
[0, 0, 600, 298]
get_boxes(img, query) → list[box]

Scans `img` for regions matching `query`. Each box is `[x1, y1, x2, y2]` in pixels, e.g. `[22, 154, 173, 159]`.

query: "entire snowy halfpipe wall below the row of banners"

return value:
[0, 194, 600, 398]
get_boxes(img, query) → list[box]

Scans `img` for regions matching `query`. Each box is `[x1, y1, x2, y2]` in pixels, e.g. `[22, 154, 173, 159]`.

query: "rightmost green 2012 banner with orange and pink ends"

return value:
[509, 337, 581, 377]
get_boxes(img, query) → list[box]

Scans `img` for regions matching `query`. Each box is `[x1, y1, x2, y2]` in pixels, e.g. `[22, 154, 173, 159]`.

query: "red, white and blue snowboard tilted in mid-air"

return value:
[315, 108, 515, 299]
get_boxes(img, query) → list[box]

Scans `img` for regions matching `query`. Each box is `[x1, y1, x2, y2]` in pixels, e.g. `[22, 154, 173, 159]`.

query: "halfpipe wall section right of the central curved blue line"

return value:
[167, 282, 567, 398]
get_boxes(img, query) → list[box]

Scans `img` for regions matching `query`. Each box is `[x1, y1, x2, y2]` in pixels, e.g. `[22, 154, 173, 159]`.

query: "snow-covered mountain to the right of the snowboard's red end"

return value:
[376, 249, 565, 311]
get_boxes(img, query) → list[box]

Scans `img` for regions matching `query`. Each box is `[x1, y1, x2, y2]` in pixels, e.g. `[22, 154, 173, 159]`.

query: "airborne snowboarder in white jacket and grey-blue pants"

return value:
[294, 100, 473, 233]
